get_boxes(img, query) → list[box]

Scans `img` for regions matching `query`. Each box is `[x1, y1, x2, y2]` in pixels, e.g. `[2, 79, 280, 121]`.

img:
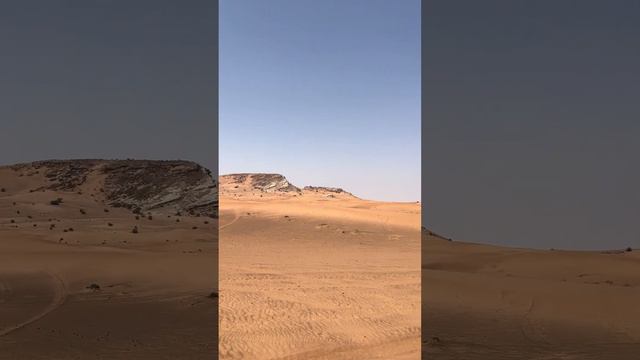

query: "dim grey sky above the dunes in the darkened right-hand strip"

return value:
[422, 0, 640, 249]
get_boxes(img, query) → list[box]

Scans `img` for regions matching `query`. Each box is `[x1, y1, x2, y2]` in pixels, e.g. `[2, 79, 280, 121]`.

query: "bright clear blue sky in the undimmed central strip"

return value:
[219, 0, 420, 201]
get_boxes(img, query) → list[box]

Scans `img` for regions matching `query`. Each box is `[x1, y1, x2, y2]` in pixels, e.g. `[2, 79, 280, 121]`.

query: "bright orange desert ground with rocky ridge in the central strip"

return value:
[219, 174, 420, 360]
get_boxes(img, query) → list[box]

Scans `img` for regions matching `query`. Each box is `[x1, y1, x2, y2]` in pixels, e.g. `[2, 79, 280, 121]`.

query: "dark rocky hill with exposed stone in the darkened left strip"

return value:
[0, 160, 218, 217]
